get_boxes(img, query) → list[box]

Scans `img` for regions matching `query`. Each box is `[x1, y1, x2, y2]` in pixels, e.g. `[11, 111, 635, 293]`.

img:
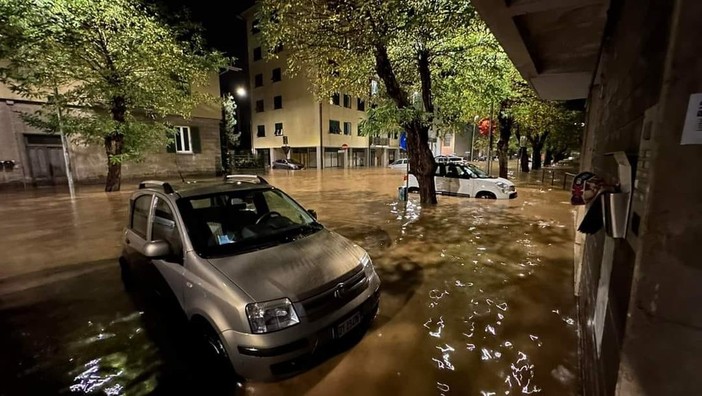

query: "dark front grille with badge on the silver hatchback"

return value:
[302, 266, 368, 321]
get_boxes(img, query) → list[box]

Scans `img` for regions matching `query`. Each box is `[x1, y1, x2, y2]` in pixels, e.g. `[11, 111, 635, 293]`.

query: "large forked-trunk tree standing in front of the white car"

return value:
[257, 0, 490, 204]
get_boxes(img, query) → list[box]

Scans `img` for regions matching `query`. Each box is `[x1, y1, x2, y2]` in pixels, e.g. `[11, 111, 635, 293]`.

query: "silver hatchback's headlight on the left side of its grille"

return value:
[246, 298, 300, 334]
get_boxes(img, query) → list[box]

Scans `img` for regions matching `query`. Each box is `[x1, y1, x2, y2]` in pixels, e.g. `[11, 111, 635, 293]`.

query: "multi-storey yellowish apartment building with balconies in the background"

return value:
[244, 8, 400, 168]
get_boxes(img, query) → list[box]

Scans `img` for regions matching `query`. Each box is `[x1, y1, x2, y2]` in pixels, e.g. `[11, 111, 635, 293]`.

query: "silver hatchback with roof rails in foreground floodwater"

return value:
[120, 175, 380, 380]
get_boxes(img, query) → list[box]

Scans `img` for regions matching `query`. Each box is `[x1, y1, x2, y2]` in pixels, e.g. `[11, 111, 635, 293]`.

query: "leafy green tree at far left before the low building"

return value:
[0, 0, 224, 191]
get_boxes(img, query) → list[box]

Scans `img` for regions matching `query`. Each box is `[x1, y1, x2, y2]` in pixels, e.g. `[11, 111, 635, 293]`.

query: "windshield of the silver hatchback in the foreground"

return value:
[178, 189, 322, 257]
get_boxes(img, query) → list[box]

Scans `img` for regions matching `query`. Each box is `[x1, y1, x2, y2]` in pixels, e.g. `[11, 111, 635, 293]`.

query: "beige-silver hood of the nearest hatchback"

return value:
[210, 229, 365, 301]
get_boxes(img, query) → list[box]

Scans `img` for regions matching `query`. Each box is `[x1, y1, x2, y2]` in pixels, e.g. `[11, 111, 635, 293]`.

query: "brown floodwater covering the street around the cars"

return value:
[0, 169, 578, 395]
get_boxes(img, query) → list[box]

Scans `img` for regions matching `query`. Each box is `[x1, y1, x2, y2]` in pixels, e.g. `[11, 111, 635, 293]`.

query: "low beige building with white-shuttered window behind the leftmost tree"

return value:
[0, 74, 221, 187]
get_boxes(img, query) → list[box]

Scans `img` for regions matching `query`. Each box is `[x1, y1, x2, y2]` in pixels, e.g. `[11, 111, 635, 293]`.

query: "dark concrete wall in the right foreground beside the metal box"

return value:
[576, 0, 702, 395]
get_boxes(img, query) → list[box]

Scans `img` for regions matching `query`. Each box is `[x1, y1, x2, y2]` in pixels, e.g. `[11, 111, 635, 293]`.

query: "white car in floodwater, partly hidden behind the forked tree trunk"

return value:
[407, 163, 517, 199]
